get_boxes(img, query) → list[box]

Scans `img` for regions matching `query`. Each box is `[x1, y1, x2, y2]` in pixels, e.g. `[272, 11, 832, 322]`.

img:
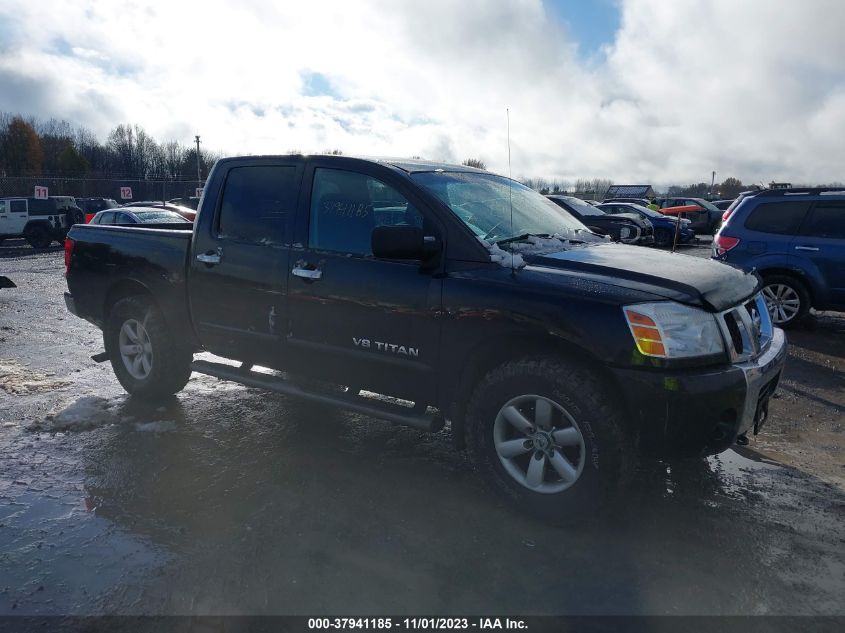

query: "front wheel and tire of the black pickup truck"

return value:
[466, 357, 635, 522]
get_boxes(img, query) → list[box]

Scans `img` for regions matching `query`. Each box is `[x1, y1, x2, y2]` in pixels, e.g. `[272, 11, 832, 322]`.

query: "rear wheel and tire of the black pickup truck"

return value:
[103, 297, 193, 399]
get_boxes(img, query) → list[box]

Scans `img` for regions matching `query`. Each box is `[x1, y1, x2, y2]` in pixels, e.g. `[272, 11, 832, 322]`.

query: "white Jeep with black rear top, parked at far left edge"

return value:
[0, 198, 84, 248]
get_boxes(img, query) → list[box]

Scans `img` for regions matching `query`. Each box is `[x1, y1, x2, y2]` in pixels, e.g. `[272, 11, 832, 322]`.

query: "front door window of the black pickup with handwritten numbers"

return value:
[308, 168, 423, 256]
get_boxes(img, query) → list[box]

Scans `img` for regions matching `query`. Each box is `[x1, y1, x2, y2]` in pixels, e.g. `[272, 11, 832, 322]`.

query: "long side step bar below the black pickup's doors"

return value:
[191, 360, 444, 433]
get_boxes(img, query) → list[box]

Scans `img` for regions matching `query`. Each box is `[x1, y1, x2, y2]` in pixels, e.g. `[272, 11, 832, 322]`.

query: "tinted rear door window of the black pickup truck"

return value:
[218, 165, 299, 244]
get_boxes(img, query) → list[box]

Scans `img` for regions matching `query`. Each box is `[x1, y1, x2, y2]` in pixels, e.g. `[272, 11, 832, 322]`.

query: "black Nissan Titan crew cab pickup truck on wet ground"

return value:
[65, 156, 786, 516]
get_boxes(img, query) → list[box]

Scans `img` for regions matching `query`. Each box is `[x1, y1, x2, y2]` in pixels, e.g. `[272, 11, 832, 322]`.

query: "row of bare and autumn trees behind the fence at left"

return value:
[0, 112, 220, 180]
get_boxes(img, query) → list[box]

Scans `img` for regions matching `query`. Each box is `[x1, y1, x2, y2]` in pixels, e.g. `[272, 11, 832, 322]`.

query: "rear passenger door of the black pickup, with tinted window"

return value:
[188, 158, 302, 365]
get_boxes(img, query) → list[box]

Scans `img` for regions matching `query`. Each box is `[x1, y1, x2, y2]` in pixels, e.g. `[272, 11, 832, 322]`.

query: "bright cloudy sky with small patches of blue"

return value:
[0, 0, 845, 184]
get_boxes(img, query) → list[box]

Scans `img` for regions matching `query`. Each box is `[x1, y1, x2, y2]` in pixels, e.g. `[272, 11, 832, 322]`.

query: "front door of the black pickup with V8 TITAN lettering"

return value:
[287, 160, 442, 403]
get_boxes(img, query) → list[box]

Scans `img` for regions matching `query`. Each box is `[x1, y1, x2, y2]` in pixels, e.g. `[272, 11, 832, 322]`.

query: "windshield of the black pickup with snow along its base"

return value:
[411, 171, 587, 242]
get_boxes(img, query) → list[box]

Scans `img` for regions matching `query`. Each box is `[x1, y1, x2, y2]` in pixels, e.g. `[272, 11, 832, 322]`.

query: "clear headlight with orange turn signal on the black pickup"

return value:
[622, 301, 725, 358]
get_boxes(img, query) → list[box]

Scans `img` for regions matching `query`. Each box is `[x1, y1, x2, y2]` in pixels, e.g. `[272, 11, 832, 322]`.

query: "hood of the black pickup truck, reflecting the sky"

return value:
[523, 244, 758, 312]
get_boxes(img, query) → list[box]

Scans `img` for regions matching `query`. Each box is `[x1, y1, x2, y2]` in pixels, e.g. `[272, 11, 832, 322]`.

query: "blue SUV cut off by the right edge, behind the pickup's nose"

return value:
[713, 188, 845, 327]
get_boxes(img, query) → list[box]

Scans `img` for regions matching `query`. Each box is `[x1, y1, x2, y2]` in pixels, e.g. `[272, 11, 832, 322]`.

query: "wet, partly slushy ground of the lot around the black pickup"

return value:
[0, 239, 845, 615]
